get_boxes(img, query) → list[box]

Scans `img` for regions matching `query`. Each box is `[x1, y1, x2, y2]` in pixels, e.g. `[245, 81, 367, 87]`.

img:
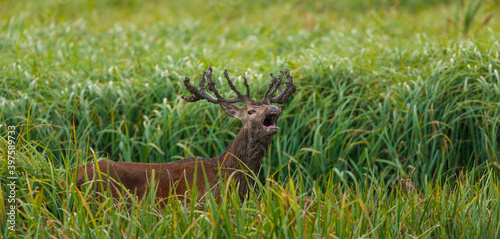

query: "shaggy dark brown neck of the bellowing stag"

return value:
[219, 127, 273, 174]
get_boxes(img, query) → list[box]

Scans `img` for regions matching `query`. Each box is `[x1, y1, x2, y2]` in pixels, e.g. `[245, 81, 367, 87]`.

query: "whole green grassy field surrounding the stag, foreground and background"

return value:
[0, 0, 500, 238]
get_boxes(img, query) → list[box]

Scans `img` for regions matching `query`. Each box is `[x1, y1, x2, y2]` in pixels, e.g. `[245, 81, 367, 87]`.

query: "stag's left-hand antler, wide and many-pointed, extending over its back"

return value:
[182, 66, 254, 104]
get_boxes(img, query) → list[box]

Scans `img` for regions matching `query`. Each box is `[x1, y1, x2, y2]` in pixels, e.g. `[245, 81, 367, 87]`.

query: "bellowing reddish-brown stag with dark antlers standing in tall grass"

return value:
[77, 67, 296, 203]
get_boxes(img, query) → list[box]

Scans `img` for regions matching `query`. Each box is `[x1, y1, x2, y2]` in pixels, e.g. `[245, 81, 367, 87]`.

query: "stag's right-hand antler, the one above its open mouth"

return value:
[262, 69, 297, 104]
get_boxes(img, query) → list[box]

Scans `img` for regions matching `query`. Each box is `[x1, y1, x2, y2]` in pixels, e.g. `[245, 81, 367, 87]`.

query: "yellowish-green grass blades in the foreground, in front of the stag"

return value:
[1, 134, 500, 238]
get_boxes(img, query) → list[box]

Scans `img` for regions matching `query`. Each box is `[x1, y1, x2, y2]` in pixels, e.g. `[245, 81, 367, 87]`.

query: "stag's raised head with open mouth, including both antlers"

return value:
[182, 67, 296, 136]
